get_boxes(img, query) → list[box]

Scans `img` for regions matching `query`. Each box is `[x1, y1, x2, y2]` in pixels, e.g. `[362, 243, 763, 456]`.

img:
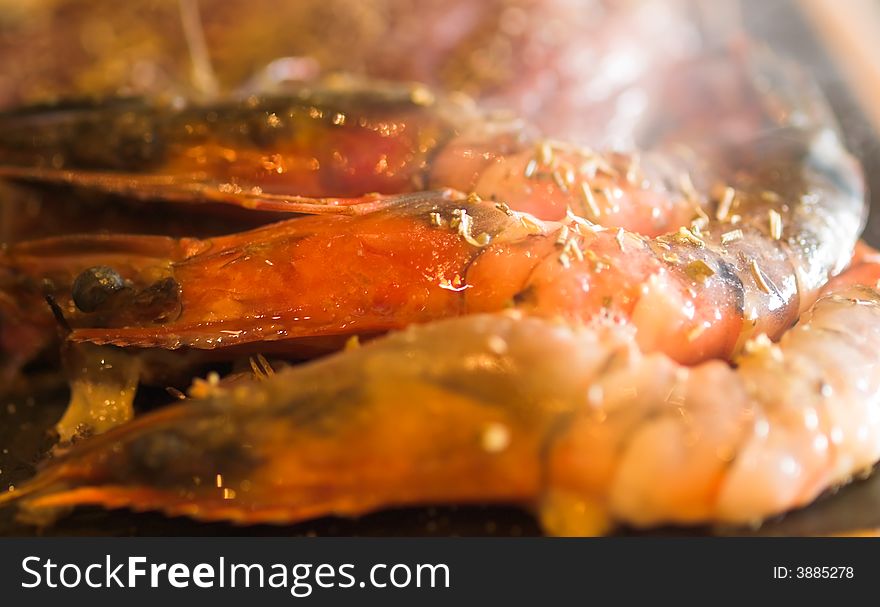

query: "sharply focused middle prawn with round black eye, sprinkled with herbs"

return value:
[6, 73, 864, 370]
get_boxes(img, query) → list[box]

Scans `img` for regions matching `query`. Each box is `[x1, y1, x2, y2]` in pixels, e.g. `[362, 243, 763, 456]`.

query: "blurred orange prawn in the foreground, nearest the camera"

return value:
[6, 265, 880, 534]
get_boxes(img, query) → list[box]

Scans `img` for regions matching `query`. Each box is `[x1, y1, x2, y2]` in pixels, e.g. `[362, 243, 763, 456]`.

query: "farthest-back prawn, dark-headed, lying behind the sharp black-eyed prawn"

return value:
[0, 79, 694, 233]
